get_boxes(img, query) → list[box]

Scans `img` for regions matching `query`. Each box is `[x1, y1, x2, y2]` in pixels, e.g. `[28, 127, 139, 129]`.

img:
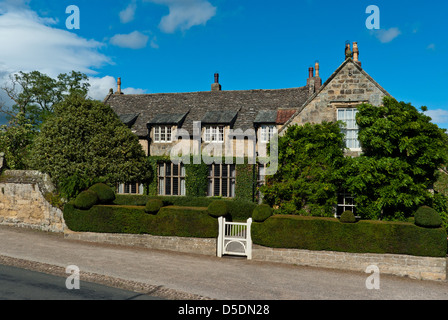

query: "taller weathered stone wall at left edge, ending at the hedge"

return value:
[0, 170, 66, 232]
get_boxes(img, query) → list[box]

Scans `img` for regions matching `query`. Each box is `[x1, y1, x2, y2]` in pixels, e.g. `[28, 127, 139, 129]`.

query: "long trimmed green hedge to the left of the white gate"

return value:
[63, 203, 218, 238]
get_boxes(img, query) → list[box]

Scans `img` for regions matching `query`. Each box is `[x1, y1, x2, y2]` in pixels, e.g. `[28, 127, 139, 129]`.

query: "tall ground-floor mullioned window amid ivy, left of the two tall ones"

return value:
[158, 162, 185, 196]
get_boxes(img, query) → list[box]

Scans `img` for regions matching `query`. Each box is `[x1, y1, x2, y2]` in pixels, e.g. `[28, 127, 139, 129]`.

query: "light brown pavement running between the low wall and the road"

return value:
[0, 226, 448, 300]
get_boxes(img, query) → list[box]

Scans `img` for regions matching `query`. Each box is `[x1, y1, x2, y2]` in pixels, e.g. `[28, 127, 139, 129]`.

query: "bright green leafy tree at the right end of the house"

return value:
[339, 97, 448, 220]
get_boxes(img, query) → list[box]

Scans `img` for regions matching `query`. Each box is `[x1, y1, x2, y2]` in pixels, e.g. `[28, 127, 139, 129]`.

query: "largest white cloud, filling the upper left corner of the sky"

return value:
[0, 7, 111, 76]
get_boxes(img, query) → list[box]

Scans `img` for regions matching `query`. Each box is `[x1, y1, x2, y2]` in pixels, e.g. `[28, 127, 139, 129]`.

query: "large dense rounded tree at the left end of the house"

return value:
[31, 95, 151, 198]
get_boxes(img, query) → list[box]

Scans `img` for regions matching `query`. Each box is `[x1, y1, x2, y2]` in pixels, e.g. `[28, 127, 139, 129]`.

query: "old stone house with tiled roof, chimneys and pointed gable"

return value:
[104, 42, 390, 203]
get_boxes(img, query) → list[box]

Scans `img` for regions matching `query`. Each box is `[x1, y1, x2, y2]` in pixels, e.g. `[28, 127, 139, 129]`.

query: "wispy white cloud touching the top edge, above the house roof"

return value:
[145, 0, 216, 33]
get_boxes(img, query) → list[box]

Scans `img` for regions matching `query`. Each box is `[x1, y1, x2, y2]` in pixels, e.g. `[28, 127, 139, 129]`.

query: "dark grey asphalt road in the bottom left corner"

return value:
[0, 265, 160, 300]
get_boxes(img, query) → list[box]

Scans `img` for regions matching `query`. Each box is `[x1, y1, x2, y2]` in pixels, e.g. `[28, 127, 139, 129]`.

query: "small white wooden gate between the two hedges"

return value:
[217, 217, 252, 260]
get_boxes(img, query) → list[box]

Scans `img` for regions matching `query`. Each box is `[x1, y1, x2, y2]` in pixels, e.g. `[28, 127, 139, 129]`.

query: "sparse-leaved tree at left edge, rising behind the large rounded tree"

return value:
[0, 71, 90, 124]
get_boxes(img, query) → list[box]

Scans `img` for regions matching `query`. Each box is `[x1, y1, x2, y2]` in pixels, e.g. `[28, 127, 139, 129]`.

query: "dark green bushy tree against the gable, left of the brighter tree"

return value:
[260, 122, 344, 216]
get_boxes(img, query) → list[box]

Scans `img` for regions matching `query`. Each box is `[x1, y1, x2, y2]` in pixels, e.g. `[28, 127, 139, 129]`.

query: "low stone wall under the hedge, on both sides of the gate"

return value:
[64, 231, 447, 280]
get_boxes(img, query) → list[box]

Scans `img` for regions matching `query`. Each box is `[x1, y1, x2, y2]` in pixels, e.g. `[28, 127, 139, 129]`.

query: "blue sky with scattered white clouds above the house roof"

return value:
[0, 0, 448, 128]
